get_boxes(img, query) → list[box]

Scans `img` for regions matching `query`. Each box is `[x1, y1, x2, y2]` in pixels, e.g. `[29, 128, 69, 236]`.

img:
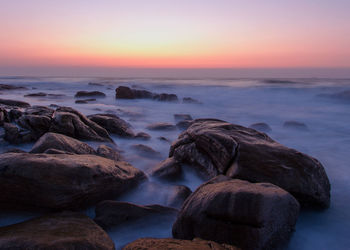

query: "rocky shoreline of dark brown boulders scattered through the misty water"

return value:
[0, 83, 330, 249]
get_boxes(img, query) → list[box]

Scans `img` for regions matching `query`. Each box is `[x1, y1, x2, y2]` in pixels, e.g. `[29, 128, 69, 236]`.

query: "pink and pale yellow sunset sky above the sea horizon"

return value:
[0, 0, 350, 76]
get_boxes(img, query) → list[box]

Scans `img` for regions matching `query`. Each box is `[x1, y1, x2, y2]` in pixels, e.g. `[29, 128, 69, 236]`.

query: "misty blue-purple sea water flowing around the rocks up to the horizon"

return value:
[0, 78, 350, 249]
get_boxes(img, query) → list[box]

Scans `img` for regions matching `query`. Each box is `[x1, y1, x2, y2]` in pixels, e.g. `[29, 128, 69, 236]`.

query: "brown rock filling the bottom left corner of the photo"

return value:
[0, 212, 114, 250]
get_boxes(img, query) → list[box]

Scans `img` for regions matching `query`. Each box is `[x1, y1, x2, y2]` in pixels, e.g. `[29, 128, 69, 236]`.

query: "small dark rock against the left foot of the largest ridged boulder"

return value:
[150, 157, 182, 181]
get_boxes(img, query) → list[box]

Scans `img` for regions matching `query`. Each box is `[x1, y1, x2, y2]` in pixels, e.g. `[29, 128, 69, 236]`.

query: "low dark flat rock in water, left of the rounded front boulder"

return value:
[94, 200, 178, 229]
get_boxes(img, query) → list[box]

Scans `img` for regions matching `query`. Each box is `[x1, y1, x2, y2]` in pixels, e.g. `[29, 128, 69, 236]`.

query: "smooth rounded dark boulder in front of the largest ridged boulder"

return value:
[173, 176, 299, 249]
